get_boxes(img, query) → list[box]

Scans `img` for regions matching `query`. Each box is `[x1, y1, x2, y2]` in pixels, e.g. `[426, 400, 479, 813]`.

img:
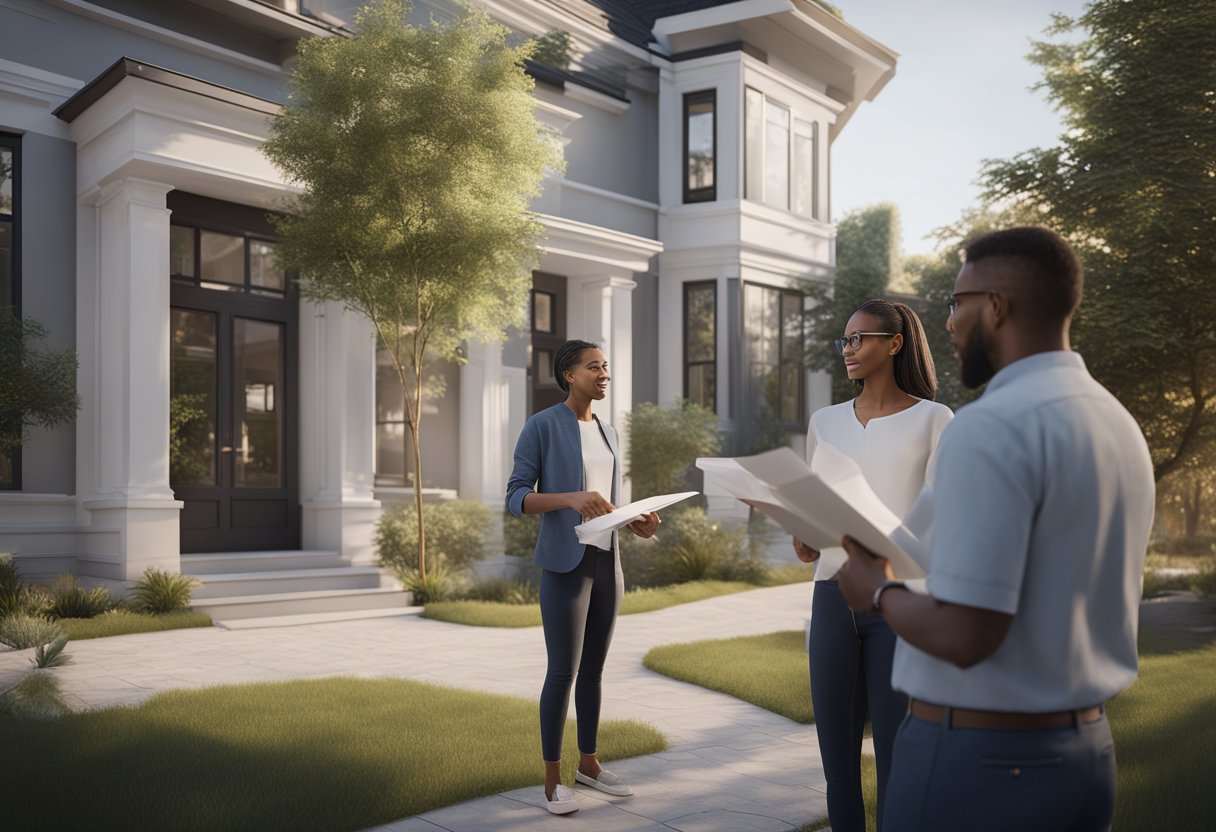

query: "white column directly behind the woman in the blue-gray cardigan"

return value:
[569, 276, 642, 504]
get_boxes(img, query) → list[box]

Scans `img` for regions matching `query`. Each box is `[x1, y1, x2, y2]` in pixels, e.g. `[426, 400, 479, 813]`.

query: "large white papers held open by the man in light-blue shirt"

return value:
[697, 444, 924, 579]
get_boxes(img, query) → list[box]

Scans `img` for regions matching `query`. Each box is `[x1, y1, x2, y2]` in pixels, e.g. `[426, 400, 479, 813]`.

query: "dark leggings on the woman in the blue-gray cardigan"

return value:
[540, 546, 624, 763]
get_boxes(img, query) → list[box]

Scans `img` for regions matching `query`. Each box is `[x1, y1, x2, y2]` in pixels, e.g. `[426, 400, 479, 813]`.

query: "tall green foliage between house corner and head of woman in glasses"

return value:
[805, 202, 902, 401]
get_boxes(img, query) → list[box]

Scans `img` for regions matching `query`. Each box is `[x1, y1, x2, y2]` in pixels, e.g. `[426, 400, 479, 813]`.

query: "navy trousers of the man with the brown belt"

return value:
[886, 715, 1115, 832]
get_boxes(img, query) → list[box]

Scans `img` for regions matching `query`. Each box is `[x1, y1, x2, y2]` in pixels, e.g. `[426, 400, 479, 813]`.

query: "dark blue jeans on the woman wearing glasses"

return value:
[809, 580, 908, 832]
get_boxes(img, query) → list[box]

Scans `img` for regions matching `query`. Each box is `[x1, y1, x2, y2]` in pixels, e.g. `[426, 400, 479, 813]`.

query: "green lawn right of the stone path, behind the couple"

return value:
[644, 630, 1216, 832]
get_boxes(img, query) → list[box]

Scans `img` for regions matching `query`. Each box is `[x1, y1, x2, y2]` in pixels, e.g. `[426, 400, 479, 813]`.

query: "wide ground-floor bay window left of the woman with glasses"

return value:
[743, 283, 805, 427]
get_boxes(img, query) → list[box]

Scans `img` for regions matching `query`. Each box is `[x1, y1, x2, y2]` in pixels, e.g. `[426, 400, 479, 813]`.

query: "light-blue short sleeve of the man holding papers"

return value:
[928, 412, 1037, 614]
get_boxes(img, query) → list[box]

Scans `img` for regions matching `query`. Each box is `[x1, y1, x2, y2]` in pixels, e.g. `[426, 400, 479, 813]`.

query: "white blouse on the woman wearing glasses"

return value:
[806, 399, 955, 580]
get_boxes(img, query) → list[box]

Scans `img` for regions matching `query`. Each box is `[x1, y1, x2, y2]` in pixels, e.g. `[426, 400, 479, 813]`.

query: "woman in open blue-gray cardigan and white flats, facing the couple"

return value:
[507, 341, 659, 815]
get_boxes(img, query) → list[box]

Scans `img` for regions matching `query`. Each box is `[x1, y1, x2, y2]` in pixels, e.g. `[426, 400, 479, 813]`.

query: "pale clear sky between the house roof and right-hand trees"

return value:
[832, 0, 1086, 254]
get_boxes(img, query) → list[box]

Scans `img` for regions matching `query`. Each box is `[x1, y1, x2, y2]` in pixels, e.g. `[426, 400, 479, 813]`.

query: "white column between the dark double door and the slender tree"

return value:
[300, 302, 381, 563]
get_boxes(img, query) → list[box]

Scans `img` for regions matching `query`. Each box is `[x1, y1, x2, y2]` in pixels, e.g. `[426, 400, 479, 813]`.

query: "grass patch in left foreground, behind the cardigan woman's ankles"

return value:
[0, 679, 665, 832]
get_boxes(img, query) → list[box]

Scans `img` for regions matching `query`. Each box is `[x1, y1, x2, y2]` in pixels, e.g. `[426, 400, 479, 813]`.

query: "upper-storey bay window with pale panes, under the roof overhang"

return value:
[743, 86, 820, 219]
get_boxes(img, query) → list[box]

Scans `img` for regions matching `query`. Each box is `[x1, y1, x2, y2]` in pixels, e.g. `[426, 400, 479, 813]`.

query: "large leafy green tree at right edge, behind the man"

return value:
[984, 0, 1216, 480]
